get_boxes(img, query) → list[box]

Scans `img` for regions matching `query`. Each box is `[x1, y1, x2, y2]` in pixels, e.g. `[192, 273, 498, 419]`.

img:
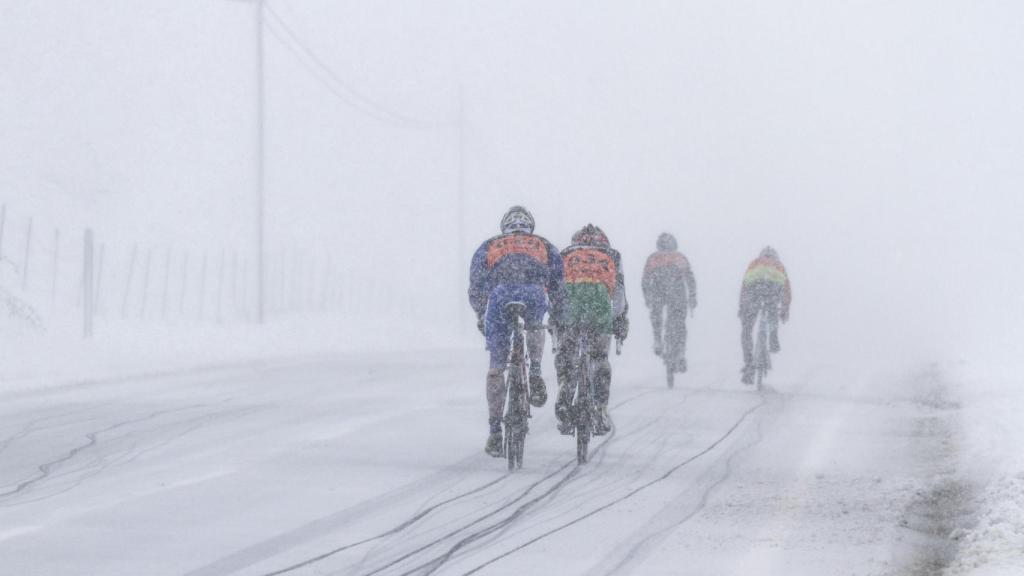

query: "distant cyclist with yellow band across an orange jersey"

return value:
[739, 246, 793, 384]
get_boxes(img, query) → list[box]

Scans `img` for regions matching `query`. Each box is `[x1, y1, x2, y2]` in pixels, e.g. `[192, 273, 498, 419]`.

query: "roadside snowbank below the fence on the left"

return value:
[0, 309, 479, 394]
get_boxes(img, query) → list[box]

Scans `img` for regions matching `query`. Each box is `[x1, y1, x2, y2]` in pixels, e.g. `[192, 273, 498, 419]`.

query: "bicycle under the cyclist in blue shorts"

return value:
[503, 302, 544, 471]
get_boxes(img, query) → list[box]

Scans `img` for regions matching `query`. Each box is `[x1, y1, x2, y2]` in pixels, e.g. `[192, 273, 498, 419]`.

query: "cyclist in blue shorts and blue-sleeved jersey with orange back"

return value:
[469, 206, 562, 457]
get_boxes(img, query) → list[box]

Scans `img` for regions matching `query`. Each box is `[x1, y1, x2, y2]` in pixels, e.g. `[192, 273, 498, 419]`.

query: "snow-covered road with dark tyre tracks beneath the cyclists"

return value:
[0, 352, 972, 576]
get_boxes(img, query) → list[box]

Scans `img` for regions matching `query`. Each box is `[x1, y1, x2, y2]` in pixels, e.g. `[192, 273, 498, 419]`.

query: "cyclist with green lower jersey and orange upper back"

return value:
[555, 224, 630, 436]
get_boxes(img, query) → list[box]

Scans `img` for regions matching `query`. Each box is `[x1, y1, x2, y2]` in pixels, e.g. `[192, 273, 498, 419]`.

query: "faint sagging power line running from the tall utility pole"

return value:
[263, 2, 454, 130]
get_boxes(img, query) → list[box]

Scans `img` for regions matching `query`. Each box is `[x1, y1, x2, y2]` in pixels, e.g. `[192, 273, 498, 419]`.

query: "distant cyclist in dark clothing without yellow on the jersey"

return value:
[642, 233, 697, 372]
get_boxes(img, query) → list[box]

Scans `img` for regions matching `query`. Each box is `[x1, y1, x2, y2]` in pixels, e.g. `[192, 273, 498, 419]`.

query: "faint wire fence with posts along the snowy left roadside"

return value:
[0, 204, 362, 336]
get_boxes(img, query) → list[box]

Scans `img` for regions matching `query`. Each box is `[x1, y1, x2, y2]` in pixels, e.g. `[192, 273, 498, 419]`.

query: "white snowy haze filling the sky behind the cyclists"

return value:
[0, 0, 1024, 368]
